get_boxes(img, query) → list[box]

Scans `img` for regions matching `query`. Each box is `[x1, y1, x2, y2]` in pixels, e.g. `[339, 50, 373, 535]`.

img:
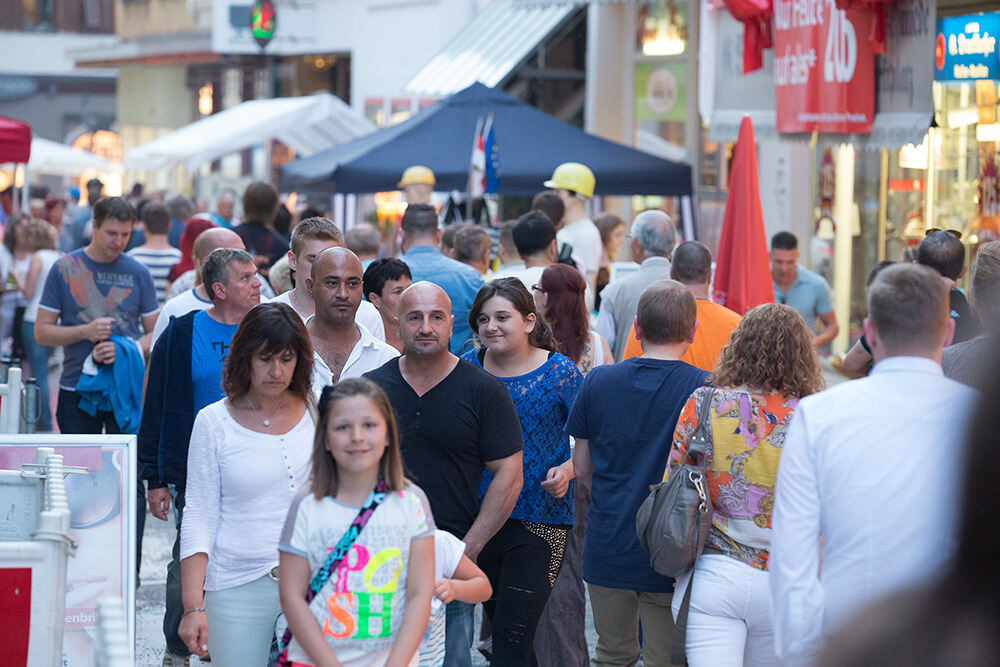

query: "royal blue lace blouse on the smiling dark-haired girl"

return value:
[462, 350, 583, 526]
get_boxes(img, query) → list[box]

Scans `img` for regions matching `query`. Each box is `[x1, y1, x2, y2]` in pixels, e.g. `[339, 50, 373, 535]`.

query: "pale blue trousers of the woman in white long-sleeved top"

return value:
[205, 575, 281, 667]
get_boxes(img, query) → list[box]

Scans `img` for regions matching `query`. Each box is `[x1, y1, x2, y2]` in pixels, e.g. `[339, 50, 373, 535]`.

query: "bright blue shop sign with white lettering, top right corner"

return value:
[934, 12, 1000, 81]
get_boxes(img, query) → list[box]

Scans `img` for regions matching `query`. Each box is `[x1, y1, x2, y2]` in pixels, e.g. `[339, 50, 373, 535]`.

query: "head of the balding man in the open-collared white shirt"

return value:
[306, 246, 363, 328]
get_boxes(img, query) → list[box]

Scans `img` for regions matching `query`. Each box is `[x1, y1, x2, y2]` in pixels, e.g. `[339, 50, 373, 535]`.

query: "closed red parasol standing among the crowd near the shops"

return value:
[713, 116, 774, 315]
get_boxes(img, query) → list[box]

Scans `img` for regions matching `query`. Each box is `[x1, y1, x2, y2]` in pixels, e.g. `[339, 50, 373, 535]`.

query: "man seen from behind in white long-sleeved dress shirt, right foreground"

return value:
[770, 264, 976, 665]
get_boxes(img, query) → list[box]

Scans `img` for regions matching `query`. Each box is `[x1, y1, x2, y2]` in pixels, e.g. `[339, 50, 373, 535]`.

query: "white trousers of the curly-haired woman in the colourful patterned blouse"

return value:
[672, 554, 781, 667]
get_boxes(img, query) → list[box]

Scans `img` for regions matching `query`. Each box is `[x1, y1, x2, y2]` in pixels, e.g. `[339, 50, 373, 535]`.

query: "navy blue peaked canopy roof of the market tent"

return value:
[281, 83, 692, 200]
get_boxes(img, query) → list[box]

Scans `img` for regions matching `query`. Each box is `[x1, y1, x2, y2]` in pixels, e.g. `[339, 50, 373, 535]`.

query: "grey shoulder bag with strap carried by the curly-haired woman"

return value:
[635, 388, 715, 665]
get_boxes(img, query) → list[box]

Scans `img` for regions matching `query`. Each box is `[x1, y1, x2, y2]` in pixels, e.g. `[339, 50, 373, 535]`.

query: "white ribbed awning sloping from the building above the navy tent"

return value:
[403, 0, 575, 97]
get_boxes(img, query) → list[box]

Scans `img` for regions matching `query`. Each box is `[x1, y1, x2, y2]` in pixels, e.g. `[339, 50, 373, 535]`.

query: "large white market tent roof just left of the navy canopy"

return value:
[125, 94, 375, 171]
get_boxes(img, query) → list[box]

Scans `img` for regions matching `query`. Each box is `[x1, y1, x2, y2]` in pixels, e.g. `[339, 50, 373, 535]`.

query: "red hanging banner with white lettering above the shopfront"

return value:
[774, 0, 875, 134]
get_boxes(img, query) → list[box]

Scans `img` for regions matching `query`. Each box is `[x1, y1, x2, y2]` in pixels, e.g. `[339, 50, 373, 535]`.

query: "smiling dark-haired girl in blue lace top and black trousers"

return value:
[463, 278, 583, 665]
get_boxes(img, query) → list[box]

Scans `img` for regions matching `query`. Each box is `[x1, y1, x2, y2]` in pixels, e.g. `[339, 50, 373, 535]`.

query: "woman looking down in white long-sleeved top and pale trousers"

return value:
[178, 303, 315, 667]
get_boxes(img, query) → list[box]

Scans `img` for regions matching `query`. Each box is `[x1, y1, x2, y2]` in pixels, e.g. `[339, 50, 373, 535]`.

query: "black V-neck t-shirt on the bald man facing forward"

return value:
[365, 358, 523, 538]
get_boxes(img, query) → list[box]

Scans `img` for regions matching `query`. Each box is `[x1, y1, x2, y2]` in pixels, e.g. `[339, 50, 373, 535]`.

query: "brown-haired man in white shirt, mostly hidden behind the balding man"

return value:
[271, 217, 385, 341]
